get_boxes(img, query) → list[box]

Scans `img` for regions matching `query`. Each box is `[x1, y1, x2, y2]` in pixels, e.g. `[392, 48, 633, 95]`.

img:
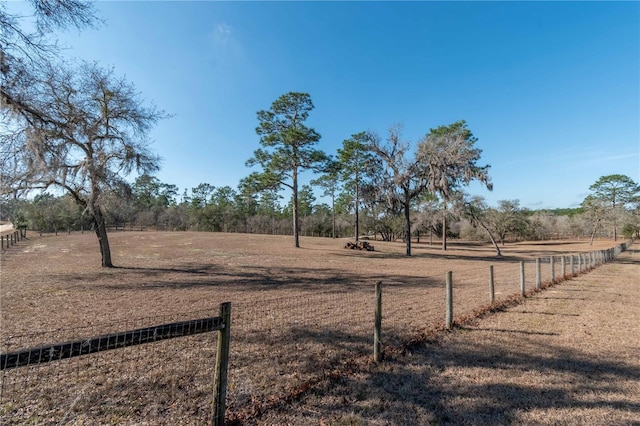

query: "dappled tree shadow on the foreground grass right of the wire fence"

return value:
[284, 330, 640, 425]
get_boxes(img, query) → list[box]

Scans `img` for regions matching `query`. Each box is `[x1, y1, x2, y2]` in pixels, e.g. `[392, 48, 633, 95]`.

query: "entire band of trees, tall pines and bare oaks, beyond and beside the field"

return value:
[0, 0, 638, 267]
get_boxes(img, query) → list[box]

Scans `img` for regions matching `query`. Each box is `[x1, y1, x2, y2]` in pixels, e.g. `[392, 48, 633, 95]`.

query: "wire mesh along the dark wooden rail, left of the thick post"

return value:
[0, 311, 217, 425]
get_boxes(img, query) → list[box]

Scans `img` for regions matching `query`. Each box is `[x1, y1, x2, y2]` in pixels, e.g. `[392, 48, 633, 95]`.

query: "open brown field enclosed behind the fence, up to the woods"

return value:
[0, 232, 637, 424]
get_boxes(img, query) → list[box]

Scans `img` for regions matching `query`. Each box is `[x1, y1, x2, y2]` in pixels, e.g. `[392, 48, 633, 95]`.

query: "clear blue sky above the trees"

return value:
[17, 1, 640, 209]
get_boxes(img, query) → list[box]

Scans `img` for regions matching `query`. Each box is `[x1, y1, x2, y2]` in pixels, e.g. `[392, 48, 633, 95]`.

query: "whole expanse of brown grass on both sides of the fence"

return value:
[0, 232, 640, 425]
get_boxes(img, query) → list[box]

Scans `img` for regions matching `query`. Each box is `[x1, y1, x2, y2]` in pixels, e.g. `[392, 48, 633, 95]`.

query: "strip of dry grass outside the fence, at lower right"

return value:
[273, 248, 640, 425]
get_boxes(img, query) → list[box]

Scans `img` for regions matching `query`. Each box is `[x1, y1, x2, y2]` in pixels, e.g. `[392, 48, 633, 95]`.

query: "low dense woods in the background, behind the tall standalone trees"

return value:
[0, 171, 640, 252]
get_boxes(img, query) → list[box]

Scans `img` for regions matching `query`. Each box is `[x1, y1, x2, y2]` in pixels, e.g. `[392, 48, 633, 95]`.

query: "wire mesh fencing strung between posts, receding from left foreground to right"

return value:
[0, 244, 627, 424]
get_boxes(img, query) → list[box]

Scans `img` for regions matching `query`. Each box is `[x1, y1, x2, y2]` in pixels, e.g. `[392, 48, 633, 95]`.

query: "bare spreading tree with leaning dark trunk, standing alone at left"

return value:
[2, 64, 166, 267]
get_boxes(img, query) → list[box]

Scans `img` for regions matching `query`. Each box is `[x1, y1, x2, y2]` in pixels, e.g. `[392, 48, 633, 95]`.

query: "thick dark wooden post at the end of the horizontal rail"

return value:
[213, 302, 231, 426]
